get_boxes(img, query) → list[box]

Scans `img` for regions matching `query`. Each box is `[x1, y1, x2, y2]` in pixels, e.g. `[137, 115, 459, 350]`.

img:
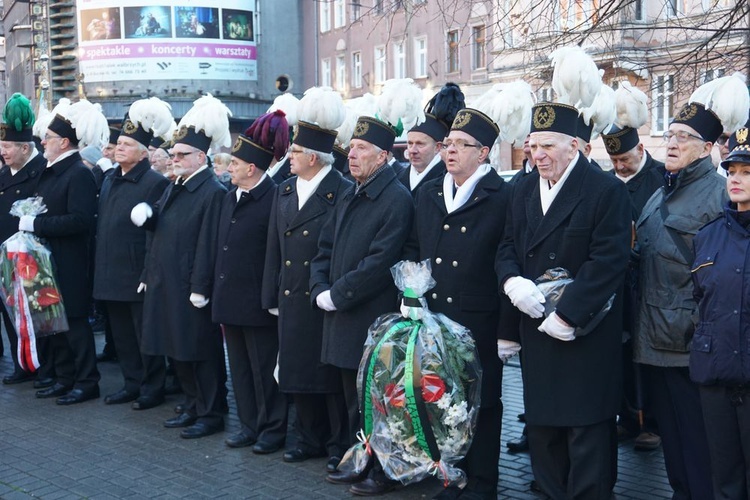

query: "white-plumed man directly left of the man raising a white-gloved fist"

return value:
[94, 97, 173, 410]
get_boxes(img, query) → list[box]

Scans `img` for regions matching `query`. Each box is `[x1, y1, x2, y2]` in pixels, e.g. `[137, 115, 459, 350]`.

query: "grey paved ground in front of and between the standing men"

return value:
[0, 335, 672, 500]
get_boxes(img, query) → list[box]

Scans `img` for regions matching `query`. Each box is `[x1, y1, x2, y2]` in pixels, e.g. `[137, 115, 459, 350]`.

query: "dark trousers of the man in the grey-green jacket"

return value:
[644, 365, 713, 500]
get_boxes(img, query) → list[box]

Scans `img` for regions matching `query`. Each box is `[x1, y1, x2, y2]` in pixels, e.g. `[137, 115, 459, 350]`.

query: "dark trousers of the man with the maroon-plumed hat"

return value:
[224, 325, 288, 446]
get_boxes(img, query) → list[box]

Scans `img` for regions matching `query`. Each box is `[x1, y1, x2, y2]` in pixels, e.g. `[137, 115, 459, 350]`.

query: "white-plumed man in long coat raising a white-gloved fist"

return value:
[131, 95, 231, 439]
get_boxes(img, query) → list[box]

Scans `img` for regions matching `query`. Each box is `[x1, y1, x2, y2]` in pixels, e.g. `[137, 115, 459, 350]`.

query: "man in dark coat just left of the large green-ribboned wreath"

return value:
[310, 117, 414, 490]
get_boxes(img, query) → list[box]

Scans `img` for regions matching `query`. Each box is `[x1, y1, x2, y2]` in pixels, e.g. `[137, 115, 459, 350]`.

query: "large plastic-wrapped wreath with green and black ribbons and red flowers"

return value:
[339, 260, 481, 486]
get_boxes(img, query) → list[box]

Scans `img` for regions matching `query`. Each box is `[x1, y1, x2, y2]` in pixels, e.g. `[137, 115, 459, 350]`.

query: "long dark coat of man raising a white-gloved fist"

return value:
[141, 168, 226, 361]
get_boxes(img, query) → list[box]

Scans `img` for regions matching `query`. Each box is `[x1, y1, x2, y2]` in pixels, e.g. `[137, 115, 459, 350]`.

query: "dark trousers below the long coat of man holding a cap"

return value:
[528, 417, 617, 500]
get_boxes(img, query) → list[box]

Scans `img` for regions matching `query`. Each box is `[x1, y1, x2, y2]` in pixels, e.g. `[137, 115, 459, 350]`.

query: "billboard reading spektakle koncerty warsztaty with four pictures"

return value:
[77, 0, 258, 82]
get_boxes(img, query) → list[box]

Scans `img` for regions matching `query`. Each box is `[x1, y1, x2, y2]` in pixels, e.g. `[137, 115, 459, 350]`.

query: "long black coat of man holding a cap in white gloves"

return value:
[496, 155, 631, 427]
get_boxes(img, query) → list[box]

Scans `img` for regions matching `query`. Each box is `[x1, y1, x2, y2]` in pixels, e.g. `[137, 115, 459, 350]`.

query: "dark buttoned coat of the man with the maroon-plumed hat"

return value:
[211, 176, 276, 327]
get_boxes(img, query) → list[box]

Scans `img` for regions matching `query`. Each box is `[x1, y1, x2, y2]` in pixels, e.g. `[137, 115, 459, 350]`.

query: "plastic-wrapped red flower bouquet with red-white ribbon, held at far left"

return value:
[0, 197, 68, 372]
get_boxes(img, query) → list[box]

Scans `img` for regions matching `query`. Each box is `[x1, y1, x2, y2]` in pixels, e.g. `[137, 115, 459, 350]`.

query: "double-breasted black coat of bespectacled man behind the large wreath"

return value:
[407, 170, 511, 408]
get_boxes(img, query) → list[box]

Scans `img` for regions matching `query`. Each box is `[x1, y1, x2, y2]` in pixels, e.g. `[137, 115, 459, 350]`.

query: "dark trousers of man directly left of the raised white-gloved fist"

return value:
[103, 301, 167, 398]
